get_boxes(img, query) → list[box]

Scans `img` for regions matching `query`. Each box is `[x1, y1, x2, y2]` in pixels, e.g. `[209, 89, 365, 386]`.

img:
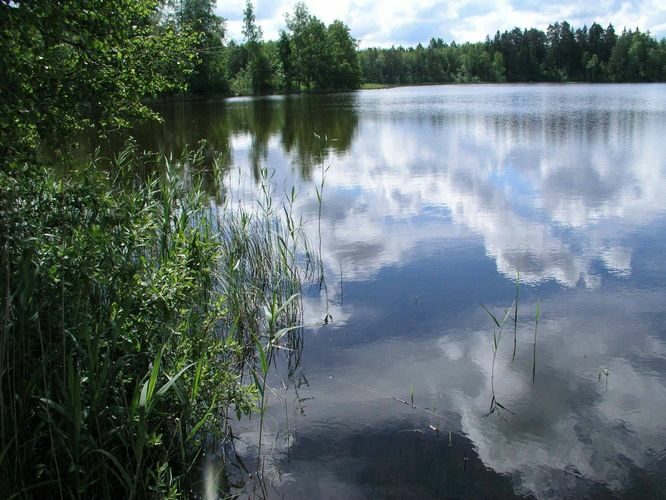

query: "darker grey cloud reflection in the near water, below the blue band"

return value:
[232, 290, 666, 498]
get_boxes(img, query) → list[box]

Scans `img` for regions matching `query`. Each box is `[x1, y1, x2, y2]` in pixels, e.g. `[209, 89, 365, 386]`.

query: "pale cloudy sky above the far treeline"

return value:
[216, 0, 666, 48]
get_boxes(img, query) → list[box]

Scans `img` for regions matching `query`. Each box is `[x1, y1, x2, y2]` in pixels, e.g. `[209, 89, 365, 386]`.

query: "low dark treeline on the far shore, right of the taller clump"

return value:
[359, 21, 666, 84]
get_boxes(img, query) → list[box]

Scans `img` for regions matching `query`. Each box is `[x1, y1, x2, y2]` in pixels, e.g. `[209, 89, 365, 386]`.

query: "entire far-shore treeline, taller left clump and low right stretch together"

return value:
[170, 0, 666, 95]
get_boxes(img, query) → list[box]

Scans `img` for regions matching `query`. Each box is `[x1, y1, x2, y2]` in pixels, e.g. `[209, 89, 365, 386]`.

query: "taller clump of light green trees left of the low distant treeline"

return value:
[169, 0, 360, 95]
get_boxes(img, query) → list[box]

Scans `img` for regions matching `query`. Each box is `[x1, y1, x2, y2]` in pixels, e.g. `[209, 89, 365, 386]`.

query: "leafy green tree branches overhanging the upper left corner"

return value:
[0, 0, 197, 159]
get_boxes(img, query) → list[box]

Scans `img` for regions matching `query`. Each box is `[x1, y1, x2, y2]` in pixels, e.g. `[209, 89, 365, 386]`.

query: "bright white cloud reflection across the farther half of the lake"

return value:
[222, 87, 666, 298]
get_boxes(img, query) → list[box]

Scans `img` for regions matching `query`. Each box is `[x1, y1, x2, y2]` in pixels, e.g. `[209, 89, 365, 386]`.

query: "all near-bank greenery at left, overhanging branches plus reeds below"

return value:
[0, 0, 308, 498]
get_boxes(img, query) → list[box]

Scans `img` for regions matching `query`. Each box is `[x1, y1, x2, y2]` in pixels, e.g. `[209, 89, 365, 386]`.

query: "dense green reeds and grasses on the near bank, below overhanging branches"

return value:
[0, 144, 302, 498]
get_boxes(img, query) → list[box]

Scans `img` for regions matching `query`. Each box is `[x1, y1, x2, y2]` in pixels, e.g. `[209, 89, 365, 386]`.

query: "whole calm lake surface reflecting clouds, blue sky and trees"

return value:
[139, 85, 666, 499]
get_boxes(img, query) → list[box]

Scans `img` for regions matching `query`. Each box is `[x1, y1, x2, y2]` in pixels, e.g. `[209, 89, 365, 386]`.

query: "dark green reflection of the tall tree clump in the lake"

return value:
[126, 93, 358, 184]
